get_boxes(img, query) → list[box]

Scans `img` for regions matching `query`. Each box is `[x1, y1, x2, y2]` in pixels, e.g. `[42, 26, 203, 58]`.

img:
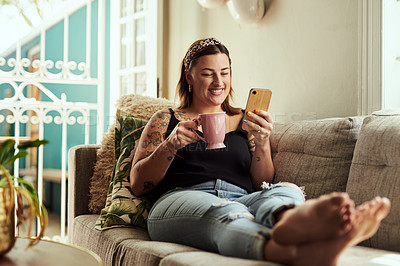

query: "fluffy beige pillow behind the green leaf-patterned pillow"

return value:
[89, 94, 174, 213]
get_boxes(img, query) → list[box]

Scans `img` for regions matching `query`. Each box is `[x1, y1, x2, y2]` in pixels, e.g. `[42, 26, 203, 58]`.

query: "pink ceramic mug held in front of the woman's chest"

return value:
[199, 112, 226, 150]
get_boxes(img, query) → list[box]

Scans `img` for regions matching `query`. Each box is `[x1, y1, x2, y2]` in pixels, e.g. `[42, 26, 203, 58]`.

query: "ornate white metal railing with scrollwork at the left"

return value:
[0, 0, 105, 242]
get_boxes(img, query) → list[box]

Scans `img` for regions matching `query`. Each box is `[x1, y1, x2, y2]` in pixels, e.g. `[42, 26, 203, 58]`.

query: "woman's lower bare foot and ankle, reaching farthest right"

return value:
[265, 197, 390, 266]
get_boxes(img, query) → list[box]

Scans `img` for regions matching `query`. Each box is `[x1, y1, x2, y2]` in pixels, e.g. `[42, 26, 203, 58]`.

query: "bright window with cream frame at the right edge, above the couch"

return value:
[358, 0, 400, 115]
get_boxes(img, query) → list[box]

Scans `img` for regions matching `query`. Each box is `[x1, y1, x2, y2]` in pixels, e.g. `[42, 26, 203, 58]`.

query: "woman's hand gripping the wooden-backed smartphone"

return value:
[246, 110, 273, 147]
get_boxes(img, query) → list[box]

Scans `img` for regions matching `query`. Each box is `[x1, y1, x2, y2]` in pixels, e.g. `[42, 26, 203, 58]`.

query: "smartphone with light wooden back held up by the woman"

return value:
[242, 88, 272, 131]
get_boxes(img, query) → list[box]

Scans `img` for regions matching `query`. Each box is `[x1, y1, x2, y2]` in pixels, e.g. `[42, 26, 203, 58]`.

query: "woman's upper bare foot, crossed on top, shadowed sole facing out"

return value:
[272, 192, 354, 245]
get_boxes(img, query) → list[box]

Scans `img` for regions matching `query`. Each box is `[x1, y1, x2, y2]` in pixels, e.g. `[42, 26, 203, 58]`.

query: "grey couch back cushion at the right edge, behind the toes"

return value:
[347, 115, 400, 251]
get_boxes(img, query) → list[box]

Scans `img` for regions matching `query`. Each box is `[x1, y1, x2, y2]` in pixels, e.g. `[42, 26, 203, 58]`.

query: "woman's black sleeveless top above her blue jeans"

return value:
[156, 109, 254, 195]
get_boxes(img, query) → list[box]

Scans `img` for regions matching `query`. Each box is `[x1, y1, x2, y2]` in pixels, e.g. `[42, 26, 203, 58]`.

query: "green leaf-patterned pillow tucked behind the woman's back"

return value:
[95, 110, 154, 230]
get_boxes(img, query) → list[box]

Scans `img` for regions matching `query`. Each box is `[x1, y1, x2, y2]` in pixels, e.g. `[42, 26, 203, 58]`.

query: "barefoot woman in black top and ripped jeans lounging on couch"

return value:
[130, 38, 390, 265]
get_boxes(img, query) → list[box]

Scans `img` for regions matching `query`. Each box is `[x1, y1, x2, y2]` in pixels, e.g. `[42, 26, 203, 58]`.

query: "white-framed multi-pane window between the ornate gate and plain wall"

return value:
[110, 0, 162, 116]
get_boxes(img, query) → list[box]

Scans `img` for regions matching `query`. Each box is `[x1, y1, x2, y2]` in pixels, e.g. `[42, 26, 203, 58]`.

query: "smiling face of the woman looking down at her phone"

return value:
[186, 53, 231, 106]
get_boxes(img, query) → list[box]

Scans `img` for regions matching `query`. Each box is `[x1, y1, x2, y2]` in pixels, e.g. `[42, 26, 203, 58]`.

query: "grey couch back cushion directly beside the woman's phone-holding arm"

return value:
[271, 117, 363, 198]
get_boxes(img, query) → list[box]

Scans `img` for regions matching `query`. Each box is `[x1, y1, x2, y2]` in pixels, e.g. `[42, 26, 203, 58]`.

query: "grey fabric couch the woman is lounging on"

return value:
[68, 108, 400, 266]
